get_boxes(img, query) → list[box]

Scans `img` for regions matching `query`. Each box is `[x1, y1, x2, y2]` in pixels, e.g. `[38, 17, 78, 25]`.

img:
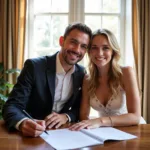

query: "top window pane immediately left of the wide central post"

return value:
[52, 0, 69, 12]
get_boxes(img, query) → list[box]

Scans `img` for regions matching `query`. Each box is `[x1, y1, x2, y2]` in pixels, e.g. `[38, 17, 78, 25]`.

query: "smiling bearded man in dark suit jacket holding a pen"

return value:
[2, 23, 91, 137]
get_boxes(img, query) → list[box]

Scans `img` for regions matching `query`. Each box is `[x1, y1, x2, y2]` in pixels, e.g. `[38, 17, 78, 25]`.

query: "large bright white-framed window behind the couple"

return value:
[26, 0, 133, 65]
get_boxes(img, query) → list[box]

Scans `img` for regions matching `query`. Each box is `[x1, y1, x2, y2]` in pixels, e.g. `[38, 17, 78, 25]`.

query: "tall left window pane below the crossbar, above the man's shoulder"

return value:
[34, 16, 51, 48]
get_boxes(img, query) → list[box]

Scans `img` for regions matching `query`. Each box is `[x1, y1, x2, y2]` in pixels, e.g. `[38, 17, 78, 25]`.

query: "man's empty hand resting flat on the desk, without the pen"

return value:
[45, 112, 68, 129]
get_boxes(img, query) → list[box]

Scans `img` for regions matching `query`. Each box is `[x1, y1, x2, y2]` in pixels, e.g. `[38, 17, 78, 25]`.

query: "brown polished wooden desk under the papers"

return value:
[0, 120, 150, 150]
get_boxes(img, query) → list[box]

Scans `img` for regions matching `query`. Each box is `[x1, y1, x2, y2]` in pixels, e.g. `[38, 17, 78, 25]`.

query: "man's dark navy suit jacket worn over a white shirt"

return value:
[2, 54, 85, 130]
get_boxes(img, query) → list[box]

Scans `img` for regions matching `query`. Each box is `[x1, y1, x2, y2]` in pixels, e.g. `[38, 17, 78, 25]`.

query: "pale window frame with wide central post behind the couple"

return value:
[25, 0, 130, 63]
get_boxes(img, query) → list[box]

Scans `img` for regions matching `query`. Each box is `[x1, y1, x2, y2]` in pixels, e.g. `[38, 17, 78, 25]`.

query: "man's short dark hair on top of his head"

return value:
[64, 23, 92, 39]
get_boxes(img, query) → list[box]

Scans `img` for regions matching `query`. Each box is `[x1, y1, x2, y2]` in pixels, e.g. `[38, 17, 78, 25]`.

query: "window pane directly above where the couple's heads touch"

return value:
[85, 15, 101, 31]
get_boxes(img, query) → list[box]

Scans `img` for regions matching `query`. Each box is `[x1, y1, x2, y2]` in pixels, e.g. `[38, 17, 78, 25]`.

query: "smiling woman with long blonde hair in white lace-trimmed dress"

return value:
[70, 29, 145, 130]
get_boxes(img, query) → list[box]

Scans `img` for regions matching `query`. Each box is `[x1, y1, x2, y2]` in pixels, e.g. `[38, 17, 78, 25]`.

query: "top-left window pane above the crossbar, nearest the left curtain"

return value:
[34, 0, 52, 13]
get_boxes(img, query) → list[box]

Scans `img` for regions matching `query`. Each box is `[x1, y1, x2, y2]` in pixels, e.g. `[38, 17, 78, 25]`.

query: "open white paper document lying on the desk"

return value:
[41, 127, 137, 150]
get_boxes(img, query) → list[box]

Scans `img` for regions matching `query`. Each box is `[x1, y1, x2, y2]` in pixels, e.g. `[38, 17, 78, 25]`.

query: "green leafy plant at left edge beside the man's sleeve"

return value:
[0, 63, 20, 119]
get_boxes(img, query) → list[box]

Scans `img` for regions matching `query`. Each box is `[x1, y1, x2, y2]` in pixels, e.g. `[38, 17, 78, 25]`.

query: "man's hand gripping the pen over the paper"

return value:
[19, 119, 46, 137]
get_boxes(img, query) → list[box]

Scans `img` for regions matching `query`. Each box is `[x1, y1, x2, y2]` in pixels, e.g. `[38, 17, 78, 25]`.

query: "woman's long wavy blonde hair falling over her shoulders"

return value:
[88, 29, 122, 97]
